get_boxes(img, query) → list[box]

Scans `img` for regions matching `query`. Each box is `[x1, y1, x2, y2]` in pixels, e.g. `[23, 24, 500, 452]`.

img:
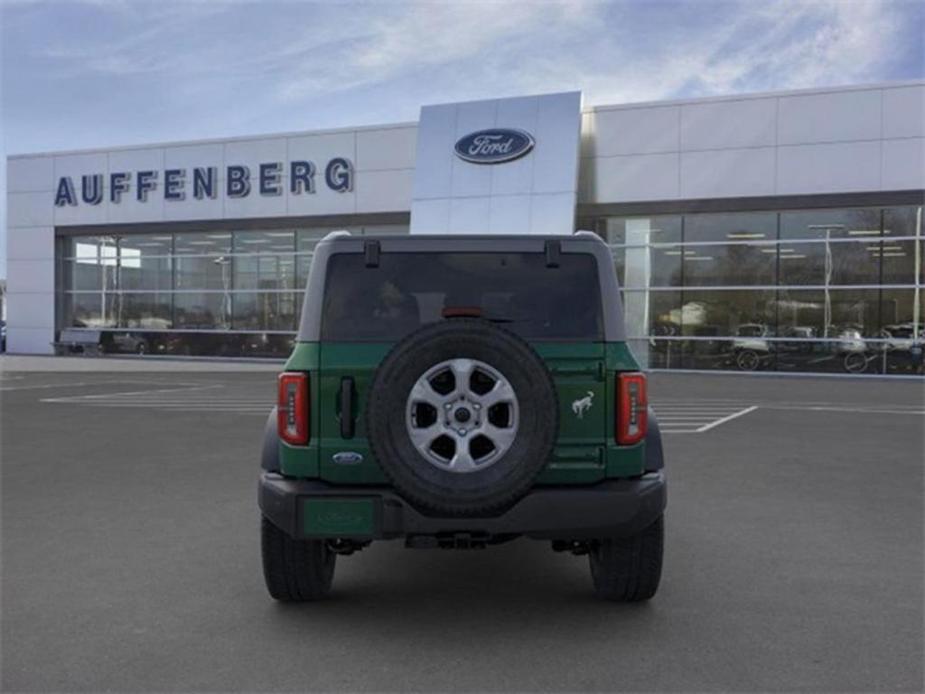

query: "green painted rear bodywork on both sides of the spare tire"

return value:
[280, 342, 645, 485]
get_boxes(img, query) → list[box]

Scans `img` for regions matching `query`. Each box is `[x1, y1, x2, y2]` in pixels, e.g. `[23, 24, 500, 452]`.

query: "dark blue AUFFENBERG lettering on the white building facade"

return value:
[55, 157, 354, 207]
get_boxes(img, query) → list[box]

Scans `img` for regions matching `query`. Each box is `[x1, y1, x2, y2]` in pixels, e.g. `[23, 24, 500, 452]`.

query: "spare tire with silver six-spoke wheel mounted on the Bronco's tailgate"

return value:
[366, 318, 559, 516]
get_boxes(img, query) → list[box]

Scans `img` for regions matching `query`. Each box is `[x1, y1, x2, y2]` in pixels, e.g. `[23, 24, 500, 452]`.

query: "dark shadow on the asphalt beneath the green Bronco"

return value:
[264, 540, 654, 641]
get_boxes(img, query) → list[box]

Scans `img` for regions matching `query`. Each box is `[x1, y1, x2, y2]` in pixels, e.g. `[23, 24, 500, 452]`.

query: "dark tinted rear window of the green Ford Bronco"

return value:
[321, 253, 603, 342]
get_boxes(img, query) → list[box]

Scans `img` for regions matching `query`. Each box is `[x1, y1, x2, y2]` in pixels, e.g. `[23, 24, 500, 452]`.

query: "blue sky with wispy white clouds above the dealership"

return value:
[0, 0, 925, 277]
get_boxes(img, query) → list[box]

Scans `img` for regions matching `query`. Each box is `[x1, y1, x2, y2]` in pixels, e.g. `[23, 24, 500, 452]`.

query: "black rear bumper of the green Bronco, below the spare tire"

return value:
[258, 471, 667, 540]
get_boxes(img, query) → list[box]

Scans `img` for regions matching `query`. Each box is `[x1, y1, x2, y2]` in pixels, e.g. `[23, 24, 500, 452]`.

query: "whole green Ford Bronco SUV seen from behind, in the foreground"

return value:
[259, 232, 666, 601]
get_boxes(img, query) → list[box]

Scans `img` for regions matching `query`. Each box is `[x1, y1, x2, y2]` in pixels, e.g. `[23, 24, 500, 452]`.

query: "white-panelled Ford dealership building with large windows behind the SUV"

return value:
[7, 81, 925, 374]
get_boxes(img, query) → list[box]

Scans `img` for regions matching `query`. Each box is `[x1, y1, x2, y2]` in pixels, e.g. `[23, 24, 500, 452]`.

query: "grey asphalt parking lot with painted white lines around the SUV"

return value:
[0, 362, 925, 691]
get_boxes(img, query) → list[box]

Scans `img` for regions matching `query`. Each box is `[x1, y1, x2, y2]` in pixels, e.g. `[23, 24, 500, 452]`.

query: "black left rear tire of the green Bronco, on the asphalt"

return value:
[260, 518, 337, 602]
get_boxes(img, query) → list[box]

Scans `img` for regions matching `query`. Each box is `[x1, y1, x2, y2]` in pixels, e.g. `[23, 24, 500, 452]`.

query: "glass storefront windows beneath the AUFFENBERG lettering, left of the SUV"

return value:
[56, 224, 408, 356]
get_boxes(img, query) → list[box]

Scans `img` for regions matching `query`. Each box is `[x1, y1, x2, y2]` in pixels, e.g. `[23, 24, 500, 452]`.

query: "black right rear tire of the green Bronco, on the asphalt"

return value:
[589, 516, 665, 602]
